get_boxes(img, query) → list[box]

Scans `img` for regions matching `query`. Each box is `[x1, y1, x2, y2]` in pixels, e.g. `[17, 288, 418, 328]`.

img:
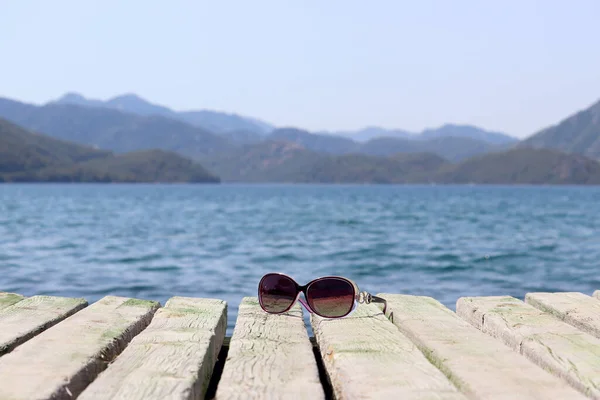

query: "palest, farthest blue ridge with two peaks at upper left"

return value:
[49, 92, 274, 135]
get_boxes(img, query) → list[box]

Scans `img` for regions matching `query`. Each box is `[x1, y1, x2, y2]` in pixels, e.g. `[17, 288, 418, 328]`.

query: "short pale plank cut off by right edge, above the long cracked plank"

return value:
[525, 292, 600, 338]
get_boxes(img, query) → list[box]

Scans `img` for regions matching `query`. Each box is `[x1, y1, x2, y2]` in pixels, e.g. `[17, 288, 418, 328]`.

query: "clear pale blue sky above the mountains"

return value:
[0, 0, 600, 137]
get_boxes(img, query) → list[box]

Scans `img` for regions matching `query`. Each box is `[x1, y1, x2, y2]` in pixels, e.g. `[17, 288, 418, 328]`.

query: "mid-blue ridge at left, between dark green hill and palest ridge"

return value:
[0, 99, 232, 158]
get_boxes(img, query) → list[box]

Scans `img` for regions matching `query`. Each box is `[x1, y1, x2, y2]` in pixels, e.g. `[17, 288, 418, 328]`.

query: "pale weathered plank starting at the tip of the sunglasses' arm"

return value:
[378, 294, 586, 400]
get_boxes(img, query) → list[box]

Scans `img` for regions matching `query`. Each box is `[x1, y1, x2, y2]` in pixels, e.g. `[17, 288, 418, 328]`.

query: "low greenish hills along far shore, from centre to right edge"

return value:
[202, 141, 600, 184]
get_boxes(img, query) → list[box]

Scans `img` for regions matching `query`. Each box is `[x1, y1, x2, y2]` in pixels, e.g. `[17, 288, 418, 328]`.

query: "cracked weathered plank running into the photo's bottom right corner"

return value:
[456, 296, 600, 399]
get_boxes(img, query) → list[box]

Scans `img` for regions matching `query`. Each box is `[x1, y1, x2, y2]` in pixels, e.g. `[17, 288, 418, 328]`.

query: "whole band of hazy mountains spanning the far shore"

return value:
[0, 91, 600, 184]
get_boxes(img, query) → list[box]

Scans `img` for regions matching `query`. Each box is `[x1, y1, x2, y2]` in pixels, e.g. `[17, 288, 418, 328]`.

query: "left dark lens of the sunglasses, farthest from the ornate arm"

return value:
[258, 274, 297, 313]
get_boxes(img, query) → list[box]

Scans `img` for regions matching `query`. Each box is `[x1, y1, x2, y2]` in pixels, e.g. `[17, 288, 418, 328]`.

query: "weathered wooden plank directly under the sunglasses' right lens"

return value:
[311, 304, 466, 400]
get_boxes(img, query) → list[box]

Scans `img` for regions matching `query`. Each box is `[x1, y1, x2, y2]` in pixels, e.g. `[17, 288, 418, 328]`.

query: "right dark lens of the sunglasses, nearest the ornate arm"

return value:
[306, 278, 354, 318]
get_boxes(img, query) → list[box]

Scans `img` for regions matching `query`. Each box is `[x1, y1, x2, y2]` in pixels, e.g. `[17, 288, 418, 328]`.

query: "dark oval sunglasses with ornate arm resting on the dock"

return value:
[258, 273, 393, 321]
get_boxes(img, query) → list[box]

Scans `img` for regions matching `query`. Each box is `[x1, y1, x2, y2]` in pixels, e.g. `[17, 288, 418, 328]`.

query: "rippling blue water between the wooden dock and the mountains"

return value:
[0, 184, 600, 334]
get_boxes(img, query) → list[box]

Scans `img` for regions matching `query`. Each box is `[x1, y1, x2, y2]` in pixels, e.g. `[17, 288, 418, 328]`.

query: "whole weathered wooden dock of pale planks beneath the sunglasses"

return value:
[0, 291, 600, 400]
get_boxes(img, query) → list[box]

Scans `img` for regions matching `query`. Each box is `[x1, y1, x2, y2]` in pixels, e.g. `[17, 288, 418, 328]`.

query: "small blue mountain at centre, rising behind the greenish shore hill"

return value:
[267, 128, 360, 154]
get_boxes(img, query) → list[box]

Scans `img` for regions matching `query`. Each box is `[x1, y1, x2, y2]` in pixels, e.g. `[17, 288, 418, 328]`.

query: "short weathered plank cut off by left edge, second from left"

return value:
[0, 296, 87, 356]
